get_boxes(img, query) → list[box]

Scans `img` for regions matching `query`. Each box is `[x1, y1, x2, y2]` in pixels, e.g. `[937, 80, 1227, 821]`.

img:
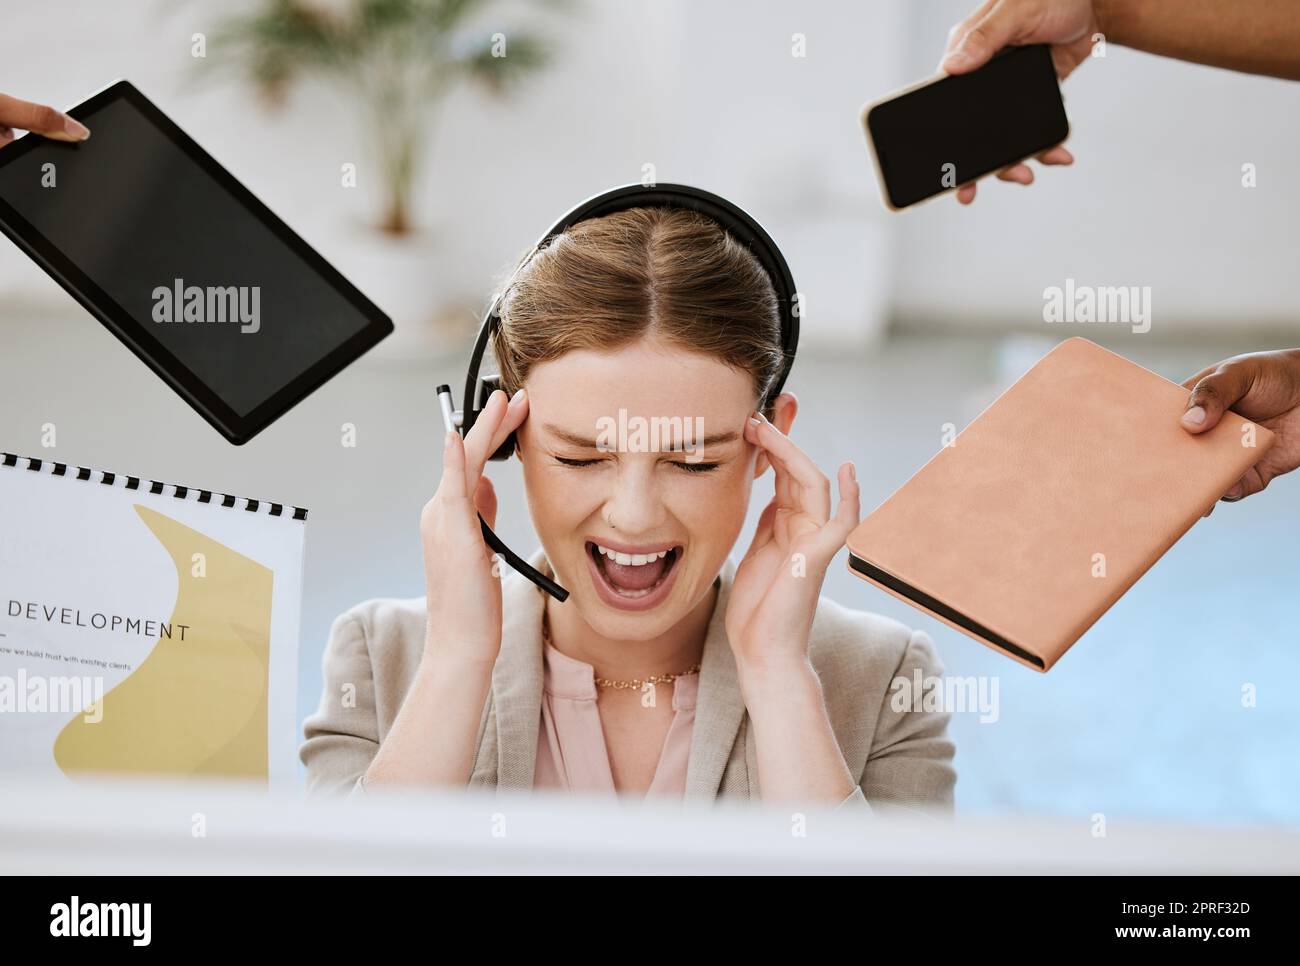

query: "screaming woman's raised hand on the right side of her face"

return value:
[727, 413, 859, 677]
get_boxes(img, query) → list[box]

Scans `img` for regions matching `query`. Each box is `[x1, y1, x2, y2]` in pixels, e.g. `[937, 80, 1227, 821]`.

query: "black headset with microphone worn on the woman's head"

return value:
[438, 183, 802, 602]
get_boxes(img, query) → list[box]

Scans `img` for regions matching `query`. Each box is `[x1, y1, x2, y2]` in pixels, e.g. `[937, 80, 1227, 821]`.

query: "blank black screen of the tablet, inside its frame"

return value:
[0, 91, 373, 417]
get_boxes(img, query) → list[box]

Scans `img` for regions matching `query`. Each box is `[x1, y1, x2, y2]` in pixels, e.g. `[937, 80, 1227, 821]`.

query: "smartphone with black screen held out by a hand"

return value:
[862, 44, 1070, 211]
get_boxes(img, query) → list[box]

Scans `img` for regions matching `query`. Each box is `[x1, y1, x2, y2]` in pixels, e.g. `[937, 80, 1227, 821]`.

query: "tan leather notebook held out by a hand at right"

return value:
[848, 338, 1273, 671]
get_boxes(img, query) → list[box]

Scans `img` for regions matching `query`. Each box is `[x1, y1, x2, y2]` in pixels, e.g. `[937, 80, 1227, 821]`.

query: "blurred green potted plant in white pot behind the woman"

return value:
[204, 0, 571, 359]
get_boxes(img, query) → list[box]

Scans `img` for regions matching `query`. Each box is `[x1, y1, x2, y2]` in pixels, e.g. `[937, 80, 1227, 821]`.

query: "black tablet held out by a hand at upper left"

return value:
[0, 81, 393, 445]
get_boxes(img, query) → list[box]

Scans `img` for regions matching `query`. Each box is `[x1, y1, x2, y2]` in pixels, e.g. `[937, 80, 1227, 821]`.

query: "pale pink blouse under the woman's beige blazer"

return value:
[533, 641, 699, 798]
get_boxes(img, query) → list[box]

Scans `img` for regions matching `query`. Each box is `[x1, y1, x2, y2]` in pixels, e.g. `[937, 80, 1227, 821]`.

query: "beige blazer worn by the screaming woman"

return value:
[299, 549, 957, 813]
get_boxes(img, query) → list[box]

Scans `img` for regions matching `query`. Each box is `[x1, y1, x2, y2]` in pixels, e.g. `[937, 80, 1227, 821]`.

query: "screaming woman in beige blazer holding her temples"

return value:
[300, 207, 956, 810]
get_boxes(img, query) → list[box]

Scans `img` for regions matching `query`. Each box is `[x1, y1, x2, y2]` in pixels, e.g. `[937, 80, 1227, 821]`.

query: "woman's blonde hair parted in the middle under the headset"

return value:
[491, 207, 784, 416]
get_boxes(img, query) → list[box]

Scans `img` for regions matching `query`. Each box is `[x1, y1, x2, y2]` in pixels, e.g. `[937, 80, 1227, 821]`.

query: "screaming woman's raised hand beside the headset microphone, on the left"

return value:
[420, 389, 528, 666]
